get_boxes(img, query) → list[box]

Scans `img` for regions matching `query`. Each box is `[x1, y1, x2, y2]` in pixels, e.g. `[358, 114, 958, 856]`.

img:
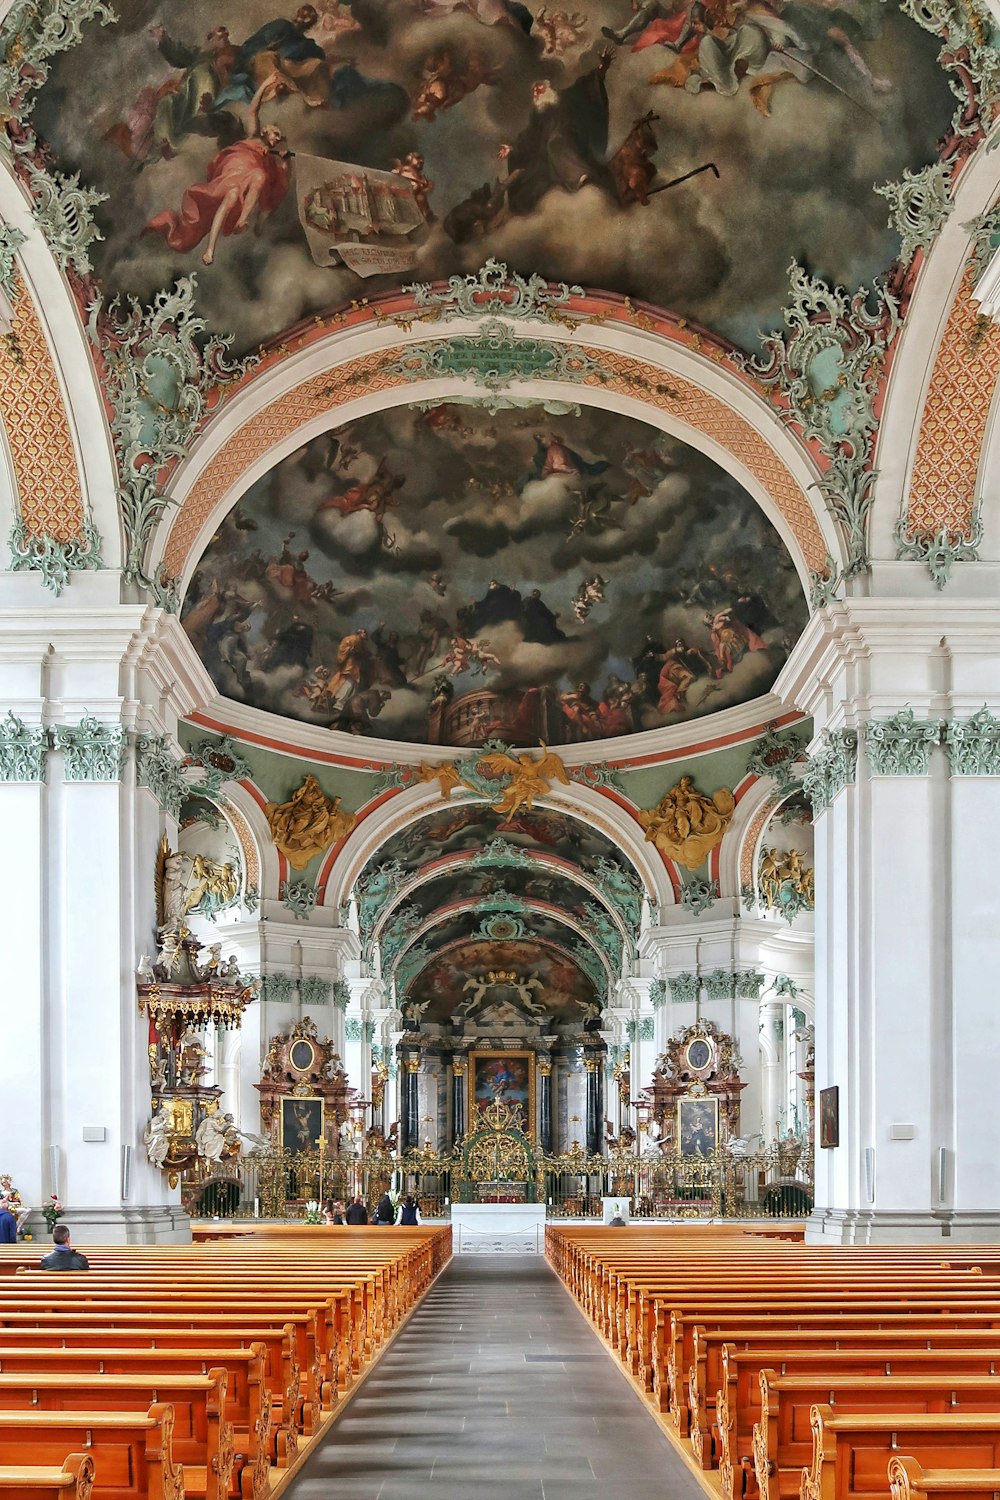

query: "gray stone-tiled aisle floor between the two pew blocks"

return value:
[286, 1256, 703, 1500]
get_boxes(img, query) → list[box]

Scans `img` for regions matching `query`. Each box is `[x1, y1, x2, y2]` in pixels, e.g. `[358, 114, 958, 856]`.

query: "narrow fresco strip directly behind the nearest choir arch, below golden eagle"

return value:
[364, 803, 638, 875]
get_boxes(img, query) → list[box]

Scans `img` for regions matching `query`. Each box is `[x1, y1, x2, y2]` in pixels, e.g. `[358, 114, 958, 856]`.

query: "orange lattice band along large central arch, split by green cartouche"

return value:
[163, 350, 828, 576]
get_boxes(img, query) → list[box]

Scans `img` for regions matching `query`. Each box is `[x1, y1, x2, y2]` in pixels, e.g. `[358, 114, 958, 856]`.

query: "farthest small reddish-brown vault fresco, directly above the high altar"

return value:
[408, 941, 595, 1025]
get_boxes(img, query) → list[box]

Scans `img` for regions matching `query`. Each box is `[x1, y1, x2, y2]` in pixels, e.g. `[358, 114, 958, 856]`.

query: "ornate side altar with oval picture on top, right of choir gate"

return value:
[643, 1022, 747, 1157]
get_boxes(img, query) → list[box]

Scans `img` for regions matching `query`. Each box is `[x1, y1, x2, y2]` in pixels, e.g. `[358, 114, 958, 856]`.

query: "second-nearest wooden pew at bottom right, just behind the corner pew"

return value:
[799, 1403, 1000, 1500]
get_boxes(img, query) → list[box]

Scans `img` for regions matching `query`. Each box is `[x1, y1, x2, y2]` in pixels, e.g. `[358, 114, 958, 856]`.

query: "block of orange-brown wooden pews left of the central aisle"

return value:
[0, 1226, 451, 1500]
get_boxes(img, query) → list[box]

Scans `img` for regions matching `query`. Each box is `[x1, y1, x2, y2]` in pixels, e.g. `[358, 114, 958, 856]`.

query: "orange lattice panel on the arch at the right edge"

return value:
[907, 269, 1000, 536]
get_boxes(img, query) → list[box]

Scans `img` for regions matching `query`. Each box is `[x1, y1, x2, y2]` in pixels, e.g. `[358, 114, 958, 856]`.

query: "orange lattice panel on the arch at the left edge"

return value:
[0, 281, 85, 542]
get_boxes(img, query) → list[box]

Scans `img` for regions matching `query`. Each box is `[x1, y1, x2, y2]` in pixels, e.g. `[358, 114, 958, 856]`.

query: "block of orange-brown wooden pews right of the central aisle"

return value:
[546, 1226, 1000, 1500]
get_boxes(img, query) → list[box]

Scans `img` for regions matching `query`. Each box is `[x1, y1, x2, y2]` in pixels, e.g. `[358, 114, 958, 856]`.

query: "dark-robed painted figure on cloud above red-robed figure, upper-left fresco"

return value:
[106, 23, 243, 168]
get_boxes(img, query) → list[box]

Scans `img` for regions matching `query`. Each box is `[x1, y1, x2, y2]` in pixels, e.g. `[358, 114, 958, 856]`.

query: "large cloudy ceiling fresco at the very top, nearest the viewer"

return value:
[36, 0, 954, 350]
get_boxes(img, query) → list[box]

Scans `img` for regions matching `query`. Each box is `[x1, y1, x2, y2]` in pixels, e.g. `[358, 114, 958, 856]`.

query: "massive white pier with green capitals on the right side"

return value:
[778, 597, 1000, 1242]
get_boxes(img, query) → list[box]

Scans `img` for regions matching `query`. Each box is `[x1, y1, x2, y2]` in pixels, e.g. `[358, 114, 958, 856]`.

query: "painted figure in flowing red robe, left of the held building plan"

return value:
[142, 81, 291, 266]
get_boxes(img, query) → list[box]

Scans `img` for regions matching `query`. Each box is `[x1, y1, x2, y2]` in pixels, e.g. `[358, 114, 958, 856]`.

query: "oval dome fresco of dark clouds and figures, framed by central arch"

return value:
[183, 405, 807, 746]
